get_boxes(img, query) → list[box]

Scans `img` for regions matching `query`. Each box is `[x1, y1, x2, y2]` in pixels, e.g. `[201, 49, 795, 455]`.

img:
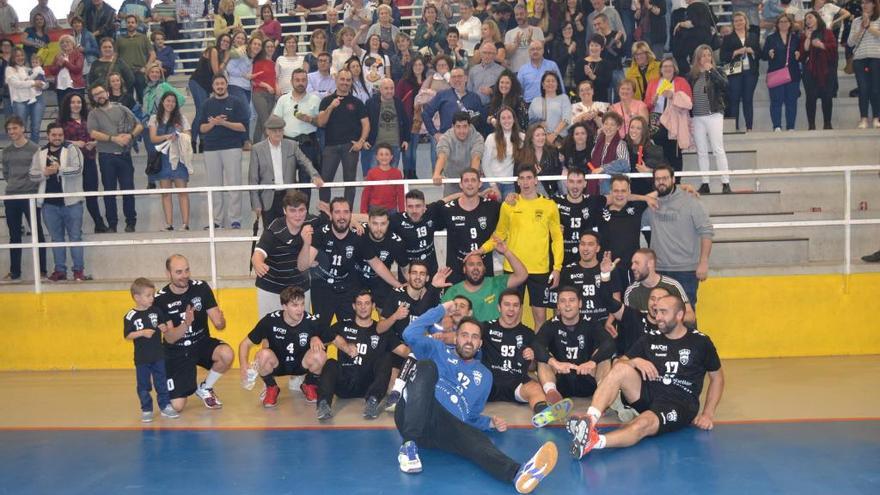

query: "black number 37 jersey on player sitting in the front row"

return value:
[535, 316, 614, 365]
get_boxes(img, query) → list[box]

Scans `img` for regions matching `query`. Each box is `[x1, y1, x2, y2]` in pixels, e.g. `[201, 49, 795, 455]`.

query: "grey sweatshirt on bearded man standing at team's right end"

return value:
[645, 188, 715, 272]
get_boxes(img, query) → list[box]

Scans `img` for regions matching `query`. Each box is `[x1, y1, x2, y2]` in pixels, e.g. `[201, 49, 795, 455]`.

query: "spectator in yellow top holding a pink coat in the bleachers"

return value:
[645, 57, 693, 172]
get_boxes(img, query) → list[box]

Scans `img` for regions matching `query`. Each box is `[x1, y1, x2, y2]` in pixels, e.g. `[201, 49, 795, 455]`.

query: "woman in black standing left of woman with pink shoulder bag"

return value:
[720, 12, 761, 132]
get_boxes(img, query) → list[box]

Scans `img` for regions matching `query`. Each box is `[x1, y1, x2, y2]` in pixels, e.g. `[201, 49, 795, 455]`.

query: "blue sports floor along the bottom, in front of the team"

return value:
[0, 421, 880, 495]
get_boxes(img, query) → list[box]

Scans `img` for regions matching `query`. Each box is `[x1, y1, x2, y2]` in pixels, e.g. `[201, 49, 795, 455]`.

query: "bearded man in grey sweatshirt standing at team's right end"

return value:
[645, 165, 715, 309]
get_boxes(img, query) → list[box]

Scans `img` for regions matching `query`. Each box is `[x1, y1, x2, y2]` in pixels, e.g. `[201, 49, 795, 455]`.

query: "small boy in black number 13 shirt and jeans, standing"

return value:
[122, 278, 180, 423]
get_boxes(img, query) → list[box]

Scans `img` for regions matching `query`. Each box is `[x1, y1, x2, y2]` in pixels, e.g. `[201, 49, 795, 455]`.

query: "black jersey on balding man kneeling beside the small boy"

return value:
[153, 280, 217, 353]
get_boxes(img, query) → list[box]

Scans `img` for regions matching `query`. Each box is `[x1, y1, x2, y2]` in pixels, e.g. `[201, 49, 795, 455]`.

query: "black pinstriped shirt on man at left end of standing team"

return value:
[255, 217, 315, 294]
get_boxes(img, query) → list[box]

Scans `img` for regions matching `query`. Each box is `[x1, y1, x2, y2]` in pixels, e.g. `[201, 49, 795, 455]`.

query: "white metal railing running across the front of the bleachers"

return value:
[0, 165, 880, 293]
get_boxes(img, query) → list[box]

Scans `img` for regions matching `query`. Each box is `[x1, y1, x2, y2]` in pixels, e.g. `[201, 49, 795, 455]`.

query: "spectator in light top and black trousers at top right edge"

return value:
[846, 0, 880, 129]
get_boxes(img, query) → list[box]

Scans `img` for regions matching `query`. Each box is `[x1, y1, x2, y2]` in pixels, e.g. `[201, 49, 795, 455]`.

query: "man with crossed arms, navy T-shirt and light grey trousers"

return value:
[197, 74, 249, 229]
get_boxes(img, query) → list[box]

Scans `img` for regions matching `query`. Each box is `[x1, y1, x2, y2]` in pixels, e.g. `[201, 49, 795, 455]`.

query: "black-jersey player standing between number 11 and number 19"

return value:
[357, 206, 409, 308]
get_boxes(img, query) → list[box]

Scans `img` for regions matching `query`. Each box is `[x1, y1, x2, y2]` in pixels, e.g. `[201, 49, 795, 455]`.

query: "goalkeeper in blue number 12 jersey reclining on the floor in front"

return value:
[394, 301, 557, 493]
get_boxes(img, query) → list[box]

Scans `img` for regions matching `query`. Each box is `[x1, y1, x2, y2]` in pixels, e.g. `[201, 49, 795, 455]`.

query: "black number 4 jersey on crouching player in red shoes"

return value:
[248, 311, 321, 367]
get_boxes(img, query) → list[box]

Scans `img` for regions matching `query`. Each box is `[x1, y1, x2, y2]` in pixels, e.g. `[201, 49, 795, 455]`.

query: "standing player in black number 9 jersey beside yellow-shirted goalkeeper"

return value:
[440, 168, 501, 284]
